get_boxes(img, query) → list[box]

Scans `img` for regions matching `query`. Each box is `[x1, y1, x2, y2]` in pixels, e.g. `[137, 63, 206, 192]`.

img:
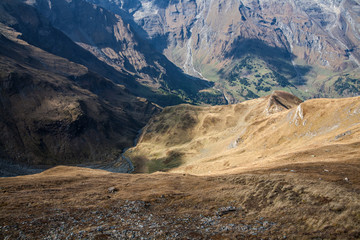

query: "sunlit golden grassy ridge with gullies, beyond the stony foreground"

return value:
[126, 91, 360, 175]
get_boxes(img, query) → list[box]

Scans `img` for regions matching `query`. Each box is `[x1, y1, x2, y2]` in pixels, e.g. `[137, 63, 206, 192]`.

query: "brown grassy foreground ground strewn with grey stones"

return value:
[0, 160, 360, 239]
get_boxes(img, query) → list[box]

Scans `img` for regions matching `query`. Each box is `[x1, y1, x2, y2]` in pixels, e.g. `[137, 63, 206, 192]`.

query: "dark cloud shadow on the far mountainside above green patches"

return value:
[225, 37, 311, 87]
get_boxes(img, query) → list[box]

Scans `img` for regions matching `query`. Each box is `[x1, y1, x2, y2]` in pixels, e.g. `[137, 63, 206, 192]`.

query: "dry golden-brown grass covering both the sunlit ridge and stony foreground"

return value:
[0, 92, 360, 239]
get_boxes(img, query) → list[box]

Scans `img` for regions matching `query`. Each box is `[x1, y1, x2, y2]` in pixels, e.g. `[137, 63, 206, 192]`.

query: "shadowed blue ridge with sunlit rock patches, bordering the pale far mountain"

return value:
[24, 0, 225, 105]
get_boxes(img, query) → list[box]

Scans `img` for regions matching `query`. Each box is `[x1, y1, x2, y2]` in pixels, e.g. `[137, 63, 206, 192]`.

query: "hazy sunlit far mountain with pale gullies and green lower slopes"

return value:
[88, 0, 360, 103]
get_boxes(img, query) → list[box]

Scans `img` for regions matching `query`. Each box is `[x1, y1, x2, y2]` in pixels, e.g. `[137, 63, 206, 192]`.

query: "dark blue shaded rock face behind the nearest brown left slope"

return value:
[0, 0, 139, 88]
